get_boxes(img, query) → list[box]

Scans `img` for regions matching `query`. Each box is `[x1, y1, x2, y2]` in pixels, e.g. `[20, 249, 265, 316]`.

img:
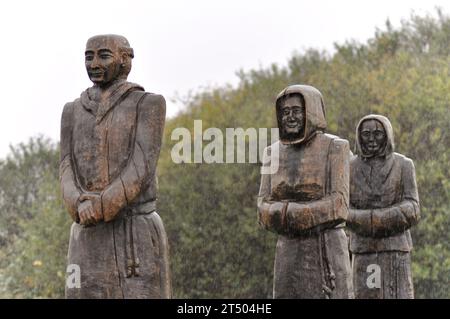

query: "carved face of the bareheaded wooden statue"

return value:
[85, 36, 123, 86]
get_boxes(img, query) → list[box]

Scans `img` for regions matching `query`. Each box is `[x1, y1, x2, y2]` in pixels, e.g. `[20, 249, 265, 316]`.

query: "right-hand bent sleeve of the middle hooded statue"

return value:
[285, 139, 351, 234]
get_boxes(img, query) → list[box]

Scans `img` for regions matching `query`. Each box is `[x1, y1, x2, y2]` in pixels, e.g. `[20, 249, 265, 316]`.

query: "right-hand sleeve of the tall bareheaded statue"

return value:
[101, 94, 166, 221]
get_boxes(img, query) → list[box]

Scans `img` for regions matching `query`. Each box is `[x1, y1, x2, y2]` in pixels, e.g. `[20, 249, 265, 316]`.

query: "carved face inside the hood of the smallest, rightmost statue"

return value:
[359, 120, 387, 156]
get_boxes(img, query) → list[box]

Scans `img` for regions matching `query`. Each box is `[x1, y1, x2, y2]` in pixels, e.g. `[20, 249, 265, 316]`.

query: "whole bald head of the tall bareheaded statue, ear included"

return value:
[85, 34, 134, 86]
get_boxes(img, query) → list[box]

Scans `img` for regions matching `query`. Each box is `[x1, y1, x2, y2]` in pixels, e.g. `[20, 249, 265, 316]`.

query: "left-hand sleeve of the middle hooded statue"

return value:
[257, 146, 287, 234]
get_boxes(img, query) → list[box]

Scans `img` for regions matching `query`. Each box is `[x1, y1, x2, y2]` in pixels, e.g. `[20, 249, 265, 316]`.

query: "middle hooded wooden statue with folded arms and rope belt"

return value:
[258, 85, 353, 298]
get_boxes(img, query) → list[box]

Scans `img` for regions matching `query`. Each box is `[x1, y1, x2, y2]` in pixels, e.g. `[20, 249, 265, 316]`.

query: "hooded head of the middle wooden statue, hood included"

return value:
[275, 85, 327, 144]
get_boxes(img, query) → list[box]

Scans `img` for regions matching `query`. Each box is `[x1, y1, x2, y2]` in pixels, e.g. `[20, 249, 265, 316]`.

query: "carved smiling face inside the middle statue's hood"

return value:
[280, 95, 305, 138]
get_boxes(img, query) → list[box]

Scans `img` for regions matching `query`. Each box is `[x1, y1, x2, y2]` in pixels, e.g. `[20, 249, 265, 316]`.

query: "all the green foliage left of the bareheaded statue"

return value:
[0, 137, 70, 298]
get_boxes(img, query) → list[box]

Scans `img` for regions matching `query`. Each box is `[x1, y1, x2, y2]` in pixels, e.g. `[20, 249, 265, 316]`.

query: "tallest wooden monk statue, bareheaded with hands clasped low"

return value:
[60, 35, 171, 298]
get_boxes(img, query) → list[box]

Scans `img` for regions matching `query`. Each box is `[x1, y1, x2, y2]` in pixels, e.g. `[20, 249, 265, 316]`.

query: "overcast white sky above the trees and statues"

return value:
[0, 0, 450, 158]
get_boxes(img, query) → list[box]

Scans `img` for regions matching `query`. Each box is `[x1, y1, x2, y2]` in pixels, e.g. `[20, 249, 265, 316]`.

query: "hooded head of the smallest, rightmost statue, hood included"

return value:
[356, 114, 394, 158]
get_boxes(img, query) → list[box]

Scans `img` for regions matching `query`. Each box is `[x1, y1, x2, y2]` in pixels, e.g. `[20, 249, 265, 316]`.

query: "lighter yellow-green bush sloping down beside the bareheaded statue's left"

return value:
[0, 174, 71, 298]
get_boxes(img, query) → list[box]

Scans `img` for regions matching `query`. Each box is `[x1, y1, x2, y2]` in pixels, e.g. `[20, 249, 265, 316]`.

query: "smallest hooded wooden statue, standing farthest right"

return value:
[347, 115, 419, 299]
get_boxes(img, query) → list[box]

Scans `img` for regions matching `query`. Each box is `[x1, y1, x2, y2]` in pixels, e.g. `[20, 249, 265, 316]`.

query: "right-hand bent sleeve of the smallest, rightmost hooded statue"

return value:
[350, 159, 420, 237]
